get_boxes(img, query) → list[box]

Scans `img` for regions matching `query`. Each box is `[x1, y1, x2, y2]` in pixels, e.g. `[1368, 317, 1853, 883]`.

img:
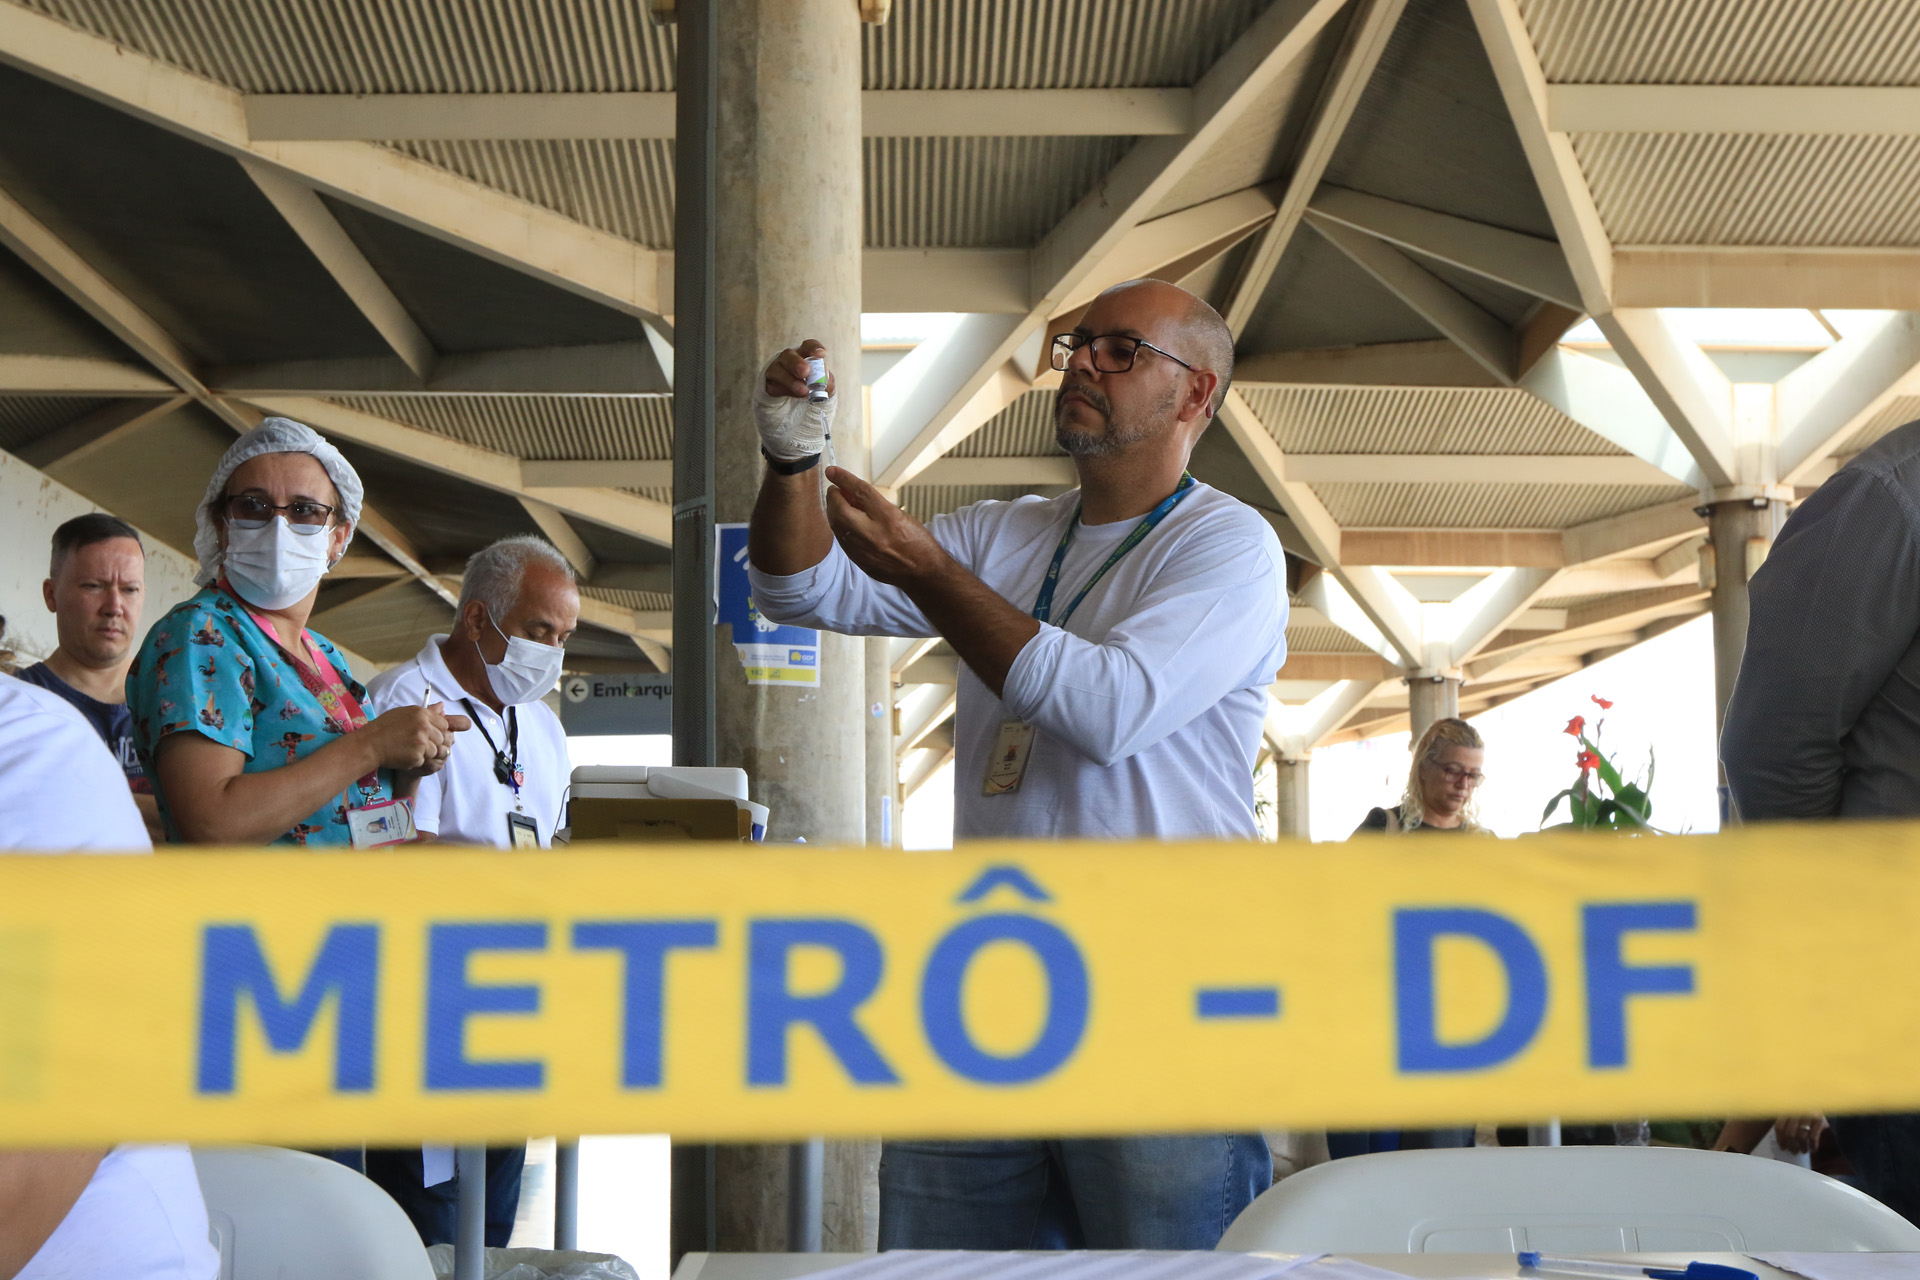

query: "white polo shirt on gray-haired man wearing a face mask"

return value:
[367, 635, 572, 848]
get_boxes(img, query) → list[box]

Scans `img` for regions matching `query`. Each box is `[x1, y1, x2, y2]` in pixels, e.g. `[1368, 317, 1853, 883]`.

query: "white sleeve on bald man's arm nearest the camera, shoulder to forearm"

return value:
[1000, 539, 1286, 766]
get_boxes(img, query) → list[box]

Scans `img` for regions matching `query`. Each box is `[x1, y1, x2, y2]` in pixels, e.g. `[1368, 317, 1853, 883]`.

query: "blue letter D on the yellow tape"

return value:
[1394, 908, 1548, 1073]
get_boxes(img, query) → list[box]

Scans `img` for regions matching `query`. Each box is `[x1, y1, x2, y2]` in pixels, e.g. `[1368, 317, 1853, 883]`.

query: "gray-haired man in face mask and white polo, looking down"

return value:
[367, 535, 580, 1247]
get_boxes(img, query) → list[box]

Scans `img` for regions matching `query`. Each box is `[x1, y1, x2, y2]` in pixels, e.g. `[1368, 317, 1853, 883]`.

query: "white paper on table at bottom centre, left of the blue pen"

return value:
[787, 1249, 1328, 1280]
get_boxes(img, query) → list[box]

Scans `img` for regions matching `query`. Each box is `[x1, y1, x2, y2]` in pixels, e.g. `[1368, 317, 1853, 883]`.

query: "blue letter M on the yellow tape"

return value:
[198, 925, 380, 1094]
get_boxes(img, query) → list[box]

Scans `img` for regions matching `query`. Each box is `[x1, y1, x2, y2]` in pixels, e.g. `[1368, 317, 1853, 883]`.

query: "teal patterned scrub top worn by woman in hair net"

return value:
[127, 587, 394, 848]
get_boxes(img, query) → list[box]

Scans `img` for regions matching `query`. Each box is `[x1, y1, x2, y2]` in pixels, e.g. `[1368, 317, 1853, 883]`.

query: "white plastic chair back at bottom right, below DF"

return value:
[1219, 1148, 1920, 1253]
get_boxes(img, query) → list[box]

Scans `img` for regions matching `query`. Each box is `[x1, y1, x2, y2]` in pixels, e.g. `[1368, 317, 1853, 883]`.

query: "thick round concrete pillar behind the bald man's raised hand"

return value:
[714, 0, 870, 1251]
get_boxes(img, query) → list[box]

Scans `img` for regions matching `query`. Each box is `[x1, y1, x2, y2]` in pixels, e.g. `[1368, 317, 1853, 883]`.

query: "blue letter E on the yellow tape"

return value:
[426, 921, 547, 1092]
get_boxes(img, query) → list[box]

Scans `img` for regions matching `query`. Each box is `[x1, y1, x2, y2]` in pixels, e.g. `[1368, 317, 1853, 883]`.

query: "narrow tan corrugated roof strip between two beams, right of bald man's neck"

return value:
[1313, 484, 1693, 530]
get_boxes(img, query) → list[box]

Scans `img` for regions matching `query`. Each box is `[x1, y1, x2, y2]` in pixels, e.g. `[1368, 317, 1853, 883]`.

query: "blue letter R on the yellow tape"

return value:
[747, 919, 900, 1086]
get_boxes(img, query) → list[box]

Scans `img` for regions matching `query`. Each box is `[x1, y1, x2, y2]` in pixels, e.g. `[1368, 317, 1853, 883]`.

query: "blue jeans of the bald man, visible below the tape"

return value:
[879, 1134, 1273, 1249]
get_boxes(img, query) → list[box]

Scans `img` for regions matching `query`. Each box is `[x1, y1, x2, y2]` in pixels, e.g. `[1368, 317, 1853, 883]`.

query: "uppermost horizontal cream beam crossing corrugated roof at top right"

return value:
[1548, 84, 1920, 136]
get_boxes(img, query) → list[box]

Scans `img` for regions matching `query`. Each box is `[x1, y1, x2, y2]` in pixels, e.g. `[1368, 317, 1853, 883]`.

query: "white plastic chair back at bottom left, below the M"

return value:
[194, 1148, 434, 1280]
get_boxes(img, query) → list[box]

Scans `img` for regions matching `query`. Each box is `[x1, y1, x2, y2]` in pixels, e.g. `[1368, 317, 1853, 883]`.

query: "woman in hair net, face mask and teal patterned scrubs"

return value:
[127, 418, 468, 848]
